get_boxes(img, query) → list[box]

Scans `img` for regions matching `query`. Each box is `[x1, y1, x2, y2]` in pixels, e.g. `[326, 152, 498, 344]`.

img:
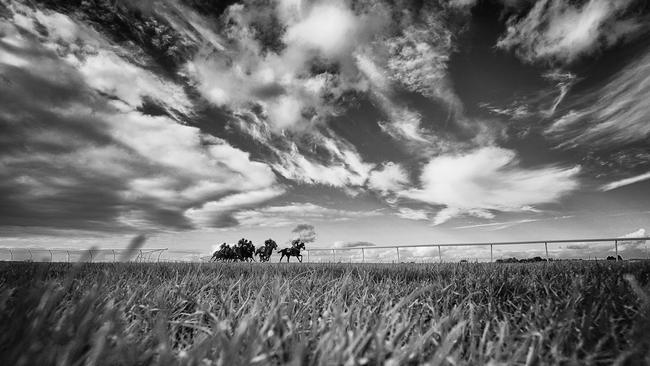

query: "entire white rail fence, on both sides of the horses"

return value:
[0, 237, 650, 263]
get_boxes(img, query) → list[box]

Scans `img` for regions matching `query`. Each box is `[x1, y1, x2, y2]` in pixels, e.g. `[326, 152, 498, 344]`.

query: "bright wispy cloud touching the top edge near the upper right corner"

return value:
[497, 0, 643, 63]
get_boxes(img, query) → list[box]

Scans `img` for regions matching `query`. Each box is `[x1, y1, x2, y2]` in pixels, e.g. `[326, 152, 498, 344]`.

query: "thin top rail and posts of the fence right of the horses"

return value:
[305, 236, 650, 262]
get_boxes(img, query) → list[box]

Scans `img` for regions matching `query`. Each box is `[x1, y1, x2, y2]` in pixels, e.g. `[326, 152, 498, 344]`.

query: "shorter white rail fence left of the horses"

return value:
[0, 247, 167, 263]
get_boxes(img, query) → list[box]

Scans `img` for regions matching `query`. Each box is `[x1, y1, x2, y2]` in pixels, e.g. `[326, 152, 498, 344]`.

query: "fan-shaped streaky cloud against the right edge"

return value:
[545, 52, 650, 148]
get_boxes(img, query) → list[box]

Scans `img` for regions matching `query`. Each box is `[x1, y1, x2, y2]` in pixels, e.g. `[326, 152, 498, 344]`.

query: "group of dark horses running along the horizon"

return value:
[211, 238, 305, 262]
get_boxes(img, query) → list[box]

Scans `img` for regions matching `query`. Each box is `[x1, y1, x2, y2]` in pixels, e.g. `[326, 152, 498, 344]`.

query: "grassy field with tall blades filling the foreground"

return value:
[0, 262, 650, 365]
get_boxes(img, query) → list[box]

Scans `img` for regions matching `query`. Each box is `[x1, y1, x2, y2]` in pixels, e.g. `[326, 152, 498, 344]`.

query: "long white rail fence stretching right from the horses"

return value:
[304, 237, 650, 263]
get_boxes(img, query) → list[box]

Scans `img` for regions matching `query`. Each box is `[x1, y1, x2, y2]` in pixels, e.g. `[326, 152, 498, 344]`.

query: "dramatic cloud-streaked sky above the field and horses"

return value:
[0, 0, 650, 256]
